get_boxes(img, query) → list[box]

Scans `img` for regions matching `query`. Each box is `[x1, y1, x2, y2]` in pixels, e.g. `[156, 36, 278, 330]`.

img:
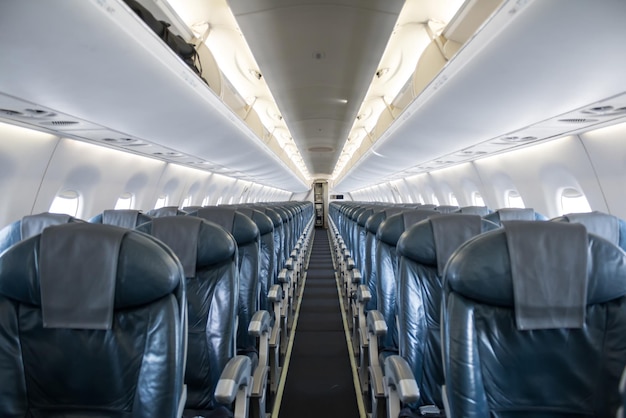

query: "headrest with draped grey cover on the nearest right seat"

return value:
[445, 221, 626, 328]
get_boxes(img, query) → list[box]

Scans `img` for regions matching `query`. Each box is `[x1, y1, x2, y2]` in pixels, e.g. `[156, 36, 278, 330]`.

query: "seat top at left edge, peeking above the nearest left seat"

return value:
[0, 212, 84, 253]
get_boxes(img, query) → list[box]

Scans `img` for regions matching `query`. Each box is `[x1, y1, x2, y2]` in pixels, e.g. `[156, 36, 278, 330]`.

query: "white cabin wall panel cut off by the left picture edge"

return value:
[0, 123, 60, 228]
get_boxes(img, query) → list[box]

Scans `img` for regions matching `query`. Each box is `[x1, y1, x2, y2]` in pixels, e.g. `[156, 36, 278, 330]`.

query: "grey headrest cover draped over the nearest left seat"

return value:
[39, 223, 126, 329]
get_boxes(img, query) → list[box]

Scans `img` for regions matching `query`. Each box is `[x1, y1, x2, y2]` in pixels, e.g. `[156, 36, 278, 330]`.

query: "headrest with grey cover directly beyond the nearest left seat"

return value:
[137, 216, 237, 277]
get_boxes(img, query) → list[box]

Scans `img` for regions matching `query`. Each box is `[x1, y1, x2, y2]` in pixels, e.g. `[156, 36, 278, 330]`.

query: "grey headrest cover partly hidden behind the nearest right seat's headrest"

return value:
[428, 214, 482, 276]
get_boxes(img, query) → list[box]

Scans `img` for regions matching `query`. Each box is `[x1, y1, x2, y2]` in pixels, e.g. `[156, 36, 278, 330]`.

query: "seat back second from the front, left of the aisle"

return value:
[137, 216, 237, 410]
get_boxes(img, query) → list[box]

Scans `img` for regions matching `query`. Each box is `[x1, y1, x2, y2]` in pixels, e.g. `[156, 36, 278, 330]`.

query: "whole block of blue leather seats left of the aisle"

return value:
[0, 202, 313, 417]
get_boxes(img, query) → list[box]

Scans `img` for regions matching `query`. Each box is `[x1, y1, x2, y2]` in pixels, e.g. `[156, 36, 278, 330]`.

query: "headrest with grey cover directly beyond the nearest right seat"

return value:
[397, 213, 498, 275]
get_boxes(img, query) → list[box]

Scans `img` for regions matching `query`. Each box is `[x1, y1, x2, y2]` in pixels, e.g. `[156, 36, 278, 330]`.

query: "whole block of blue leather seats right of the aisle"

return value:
[329, 202, 626, 417]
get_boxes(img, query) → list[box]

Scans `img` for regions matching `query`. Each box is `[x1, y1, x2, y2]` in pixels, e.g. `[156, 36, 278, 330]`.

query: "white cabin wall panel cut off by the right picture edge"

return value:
[581, 123, 626, 219]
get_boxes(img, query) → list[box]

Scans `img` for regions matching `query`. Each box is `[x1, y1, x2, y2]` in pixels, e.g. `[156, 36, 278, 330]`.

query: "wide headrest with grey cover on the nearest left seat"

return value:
[0, 223, 182, 329]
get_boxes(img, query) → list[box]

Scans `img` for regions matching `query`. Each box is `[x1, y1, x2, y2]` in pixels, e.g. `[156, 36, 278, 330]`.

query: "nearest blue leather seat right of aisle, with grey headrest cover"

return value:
[442, 221, 626, 418]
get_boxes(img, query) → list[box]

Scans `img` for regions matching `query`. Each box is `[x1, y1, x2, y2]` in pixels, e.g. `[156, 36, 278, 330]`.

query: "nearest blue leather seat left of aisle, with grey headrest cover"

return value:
[0, 223, 187, 418]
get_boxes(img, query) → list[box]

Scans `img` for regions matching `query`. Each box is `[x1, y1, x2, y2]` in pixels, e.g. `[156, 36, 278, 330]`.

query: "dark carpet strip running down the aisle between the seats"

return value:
[279, 228, 359, 418]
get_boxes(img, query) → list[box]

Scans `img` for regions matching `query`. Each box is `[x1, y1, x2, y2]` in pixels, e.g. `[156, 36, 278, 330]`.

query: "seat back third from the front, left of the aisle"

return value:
[188, 206, 260, 353]
